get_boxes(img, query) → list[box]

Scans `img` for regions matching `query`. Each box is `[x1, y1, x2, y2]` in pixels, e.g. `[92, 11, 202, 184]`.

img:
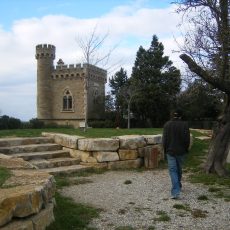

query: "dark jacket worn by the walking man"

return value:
[163, 118, 190, 155]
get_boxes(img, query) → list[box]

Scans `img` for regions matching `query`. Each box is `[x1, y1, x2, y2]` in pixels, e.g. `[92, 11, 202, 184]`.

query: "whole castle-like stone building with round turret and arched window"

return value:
[35, 44, 107, 127]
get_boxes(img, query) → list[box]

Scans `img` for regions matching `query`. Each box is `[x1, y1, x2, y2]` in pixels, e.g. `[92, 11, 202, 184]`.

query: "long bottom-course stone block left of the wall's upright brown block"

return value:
[108, 158, 143, 169]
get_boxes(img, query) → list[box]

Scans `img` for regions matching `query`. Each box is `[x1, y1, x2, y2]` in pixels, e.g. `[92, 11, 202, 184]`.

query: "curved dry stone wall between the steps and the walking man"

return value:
[42, 132, 164, 169]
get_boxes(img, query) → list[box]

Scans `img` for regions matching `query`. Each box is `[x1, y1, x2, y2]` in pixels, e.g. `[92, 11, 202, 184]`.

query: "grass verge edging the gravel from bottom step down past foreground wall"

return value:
[47, 169, 106, 230]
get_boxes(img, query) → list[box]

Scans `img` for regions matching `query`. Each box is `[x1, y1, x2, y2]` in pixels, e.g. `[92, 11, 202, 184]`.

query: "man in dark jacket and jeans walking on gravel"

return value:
[163, 111, 190, 199]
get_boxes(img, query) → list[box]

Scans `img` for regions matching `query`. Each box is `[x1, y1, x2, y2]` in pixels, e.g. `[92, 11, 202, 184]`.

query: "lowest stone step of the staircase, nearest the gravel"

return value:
[38, 165, 92, 175]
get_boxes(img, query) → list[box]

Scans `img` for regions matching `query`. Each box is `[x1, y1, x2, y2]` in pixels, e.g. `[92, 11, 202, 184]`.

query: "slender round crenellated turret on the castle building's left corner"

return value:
[35, 44, 55, 120]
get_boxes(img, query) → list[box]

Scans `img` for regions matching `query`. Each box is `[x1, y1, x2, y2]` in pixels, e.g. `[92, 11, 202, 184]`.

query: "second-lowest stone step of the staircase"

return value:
[30, 157, 80, 169]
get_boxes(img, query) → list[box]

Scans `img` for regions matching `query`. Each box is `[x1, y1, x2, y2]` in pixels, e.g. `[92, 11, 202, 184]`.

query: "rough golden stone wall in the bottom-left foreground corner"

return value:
[0, 154, 55, 230]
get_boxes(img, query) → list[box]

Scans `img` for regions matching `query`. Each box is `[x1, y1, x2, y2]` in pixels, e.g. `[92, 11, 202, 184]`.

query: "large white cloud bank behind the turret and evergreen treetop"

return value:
[0, 6, 183, 120]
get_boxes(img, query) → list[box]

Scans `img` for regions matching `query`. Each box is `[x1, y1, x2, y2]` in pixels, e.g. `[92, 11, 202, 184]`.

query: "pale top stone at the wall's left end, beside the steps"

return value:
[42, 132, 85, 149]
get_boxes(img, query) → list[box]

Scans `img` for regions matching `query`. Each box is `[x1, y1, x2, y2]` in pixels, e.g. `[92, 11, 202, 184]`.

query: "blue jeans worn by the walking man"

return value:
[167, 154, 185, 197]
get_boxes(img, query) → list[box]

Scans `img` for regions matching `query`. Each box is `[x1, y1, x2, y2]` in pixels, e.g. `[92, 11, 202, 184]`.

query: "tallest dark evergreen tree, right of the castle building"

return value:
[131, 35, 181, 127]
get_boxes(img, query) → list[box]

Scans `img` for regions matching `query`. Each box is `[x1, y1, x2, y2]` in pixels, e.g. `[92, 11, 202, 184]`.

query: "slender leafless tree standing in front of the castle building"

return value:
[76, 26, 120, 131]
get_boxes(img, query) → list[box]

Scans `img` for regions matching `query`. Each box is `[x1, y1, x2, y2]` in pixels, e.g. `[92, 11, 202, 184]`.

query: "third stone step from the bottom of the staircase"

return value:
[12, 150, 70, 161]
